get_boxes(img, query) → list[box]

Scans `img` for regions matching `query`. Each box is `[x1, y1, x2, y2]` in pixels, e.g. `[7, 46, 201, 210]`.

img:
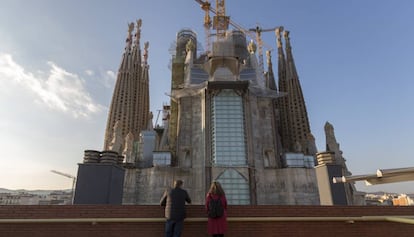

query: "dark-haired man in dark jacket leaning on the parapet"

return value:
[160, 180, 191, 237]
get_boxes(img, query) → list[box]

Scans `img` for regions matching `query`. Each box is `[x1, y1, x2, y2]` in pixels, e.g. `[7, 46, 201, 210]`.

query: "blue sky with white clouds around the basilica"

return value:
[0, 0, 414, 193]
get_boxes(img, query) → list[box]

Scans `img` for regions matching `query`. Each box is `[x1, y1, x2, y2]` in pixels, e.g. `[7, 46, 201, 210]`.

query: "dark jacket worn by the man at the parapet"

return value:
[160, 187, 191, 221]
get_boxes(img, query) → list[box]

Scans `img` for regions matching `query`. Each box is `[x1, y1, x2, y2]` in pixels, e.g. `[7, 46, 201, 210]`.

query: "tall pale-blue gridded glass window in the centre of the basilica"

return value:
[211, 89, 250, 204]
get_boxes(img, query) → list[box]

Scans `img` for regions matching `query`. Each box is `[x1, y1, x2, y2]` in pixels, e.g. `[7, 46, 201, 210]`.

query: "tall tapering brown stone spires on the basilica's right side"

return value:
[276, 29, 316, 155]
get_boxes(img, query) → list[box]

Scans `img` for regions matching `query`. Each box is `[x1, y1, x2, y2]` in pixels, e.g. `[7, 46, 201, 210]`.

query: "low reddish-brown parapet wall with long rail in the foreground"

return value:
[0, 205, 414, 237]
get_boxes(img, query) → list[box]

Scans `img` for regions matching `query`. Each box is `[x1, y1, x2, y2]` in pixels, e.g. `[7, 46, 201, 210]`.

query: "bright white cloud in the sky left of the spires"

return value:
[0, 53, 103, 118]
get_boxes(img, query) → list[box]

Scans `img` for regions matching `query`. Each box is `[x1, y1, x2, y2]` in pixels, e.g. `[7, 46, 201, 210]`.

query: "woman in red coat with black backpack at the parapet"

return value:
[205, 181, 227, 237]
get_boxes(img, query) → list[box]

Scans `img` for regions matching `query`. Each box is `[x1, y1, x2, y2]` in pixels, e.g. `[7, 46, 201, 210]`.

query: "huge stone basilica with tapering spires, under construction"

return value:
[75, 1, 357, 205]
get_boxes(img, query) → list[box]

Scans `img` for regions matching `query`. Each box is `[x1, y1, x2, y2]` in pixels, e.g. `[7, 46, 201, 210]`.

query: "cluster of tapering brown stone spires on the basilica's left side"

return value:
[104, 20, 150, 154]
